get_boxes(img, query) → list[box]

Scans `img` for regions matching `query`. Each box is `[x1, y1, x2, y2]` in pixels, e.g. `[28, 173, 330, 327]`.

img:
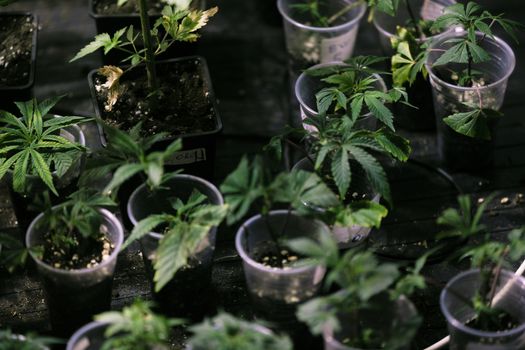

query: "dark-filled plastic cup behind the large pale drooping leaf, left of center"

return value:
[128, 175, 223, 320]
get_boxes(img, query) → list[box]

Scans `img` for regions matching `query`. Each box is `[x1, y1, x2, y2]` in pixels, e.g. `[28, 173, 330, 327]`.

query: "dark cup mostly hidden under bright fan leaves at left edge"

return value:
[6, 121, 86, 234]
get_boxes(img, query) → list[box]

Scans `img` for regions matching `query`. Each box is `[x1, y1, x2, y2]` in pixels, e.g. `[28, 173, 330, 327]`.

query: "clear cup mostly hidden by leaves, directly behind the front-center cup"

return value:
[292, 158, 381, 249]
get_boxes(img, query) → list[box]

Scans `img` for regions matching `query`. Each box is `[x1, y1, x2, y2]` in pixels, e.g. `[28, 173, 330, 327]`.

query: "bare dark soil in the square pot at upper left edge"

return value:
[0, 15, 37, 87]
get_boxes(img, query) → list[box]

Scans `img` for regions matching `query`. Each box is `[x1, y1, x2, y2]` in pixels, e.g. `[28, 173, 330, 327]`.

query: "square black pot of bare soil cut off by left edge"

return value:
[0, 12, 38, 113]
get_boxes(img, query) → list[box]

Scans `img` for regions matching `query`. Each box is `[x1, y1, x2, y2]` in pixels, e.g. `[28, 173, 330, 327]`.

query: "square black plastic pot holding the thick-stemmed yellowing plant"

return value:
[88, 56, 222, 180]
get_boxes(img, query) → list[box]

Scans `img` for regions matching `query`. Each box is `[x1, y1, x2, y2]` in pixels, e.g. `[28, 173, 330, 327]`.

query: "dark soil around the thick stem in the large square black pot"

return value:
[95, 60, 217, 136]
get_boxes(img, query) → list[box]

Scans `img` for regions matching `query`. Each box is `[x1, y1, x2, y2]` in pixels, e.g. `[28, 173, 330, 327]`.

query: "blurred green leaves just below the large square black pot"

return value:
[80, 123, 182, 195]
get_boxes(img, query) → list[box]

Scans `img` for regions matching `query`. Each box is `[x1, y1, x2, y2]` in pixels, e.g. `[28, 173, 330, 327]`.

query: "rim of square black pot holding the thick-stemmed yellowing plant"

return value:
[88, 55, 223, 146]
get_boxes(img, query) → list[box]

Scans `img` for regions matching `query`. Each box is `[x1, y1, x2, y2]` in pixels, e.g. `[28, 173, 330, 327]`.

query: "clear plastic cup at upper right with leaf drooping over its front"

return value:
[426, 31, 516, 170]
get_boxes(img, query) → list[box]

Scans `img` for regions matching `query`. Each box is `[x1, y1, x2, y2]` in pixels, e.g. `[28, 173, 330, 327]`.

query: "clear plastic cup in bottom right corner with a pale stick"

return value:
[439, 269, 525, 350]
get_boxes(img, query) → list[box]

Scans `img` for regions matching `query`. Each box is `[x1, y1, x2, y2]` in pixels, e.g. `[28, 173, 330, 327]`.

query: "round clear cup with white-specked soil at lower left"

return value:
[26, 206, 124, 336]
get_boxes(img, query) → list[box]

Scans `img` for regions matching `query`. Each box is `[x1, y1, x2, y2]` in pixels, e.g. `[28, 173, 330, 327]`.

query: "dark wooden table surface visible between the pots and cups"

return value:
[0, 0, 525, 349]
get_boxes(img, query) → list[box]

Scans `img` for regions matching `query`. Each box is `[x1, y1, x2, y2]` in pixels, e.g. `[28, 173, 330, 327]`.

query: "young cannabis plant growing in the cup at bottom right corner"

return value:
[437, 195, 525, 330]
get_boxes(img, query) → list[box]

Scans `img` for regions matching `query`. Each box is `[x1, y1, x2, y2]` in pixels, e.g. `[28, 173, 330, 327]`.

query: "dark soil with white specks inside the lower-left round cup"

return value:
[42, 232, 115, 270]
